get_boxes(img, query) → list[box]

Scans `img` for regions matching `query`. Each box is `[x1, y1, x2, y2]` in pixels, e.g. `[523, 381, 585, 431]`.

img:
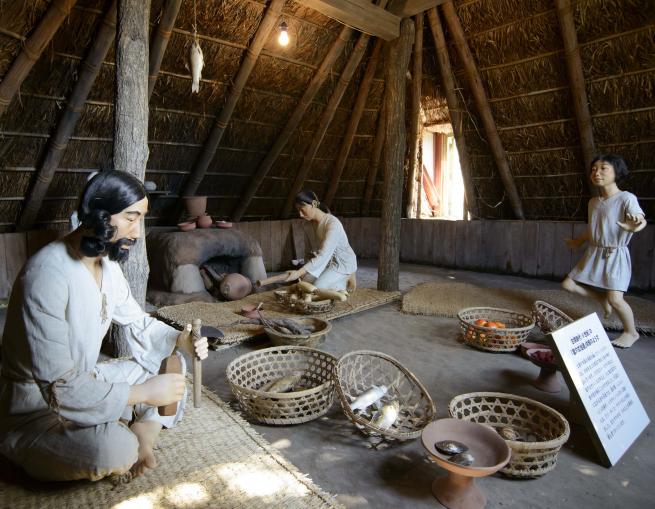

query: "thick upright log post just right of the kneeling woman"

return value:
[378, 18, 414, 291]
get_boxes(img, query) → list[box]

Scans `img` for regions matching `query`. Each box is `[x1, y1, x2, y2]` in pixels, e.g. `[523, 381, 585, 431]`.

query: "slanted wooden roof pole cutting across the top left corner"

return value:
[0, 0, 77, 117]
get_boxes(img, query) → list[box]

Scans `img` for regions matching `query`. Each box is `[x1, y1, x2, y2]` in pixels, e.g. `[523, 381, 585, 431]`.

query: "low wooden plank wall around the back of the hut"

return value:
[0, 217, 655, 299]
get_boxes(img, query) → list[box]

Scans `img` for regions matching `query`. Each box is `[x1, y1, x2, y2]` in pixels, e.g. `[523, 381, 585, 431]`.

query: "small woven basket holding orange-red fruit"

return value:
[457, 307, 534, 352]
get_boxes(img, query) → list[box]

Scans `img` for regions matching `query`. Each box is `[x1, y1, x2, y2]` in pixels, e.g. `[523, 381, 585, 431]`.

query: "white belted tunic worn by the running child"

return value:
[569, 191, 644, 292]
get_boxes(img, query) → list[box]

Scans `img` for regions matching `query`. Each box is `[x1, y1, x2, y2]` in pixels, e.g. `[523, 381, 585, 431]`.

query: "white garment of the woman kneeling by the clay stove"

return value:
[305, 214, 357, 290]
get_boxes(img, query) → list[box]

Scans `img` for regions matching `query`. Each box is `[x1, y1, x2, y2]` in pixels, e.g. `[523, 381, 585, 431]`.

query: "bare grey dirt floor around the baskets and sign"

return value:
[203, 264, 655, 509]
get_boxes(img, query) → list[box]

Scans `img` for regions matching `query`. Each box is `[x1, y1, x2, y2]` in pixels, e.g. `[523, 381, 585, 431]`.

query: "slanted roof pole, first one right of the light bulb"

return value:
[232, 27, 353, 221]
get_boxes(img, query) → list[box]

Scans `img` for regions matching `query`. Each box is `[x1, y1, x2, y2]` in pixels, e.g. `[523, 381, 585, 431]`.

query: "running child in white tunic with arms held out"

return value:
[562, 154, 646, 348]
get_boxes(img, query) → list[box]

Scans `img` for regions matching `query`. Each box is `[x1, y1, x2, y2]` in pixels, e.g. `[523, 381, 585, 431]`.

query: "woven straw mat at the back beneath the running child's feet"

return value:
[402, 283, 655, 334]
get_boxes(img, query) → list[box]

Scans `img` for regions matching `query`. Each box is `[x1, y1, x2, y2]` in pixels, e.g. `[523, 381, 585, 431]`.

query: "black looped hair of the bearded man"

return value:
[77, 170, 147, 257]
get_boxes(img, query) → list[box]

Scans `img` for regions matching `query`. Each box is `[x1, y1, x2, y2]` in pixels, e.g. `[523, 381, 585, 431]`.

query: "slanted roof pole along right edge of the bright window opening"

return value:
[428, 8, 480, 217]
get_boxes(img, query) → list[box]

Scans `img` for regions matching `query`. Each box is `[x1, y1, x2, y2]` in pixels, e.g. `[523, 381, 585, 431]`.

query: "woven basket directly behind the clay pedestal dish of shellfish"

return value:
[449, 392, 570, 479]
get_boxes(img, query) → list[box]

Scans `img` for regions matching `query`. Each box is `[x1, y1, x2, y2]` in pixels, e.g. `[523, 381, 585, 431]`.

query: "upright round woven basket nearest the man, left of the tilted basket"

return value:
[226, 346, 337, 425]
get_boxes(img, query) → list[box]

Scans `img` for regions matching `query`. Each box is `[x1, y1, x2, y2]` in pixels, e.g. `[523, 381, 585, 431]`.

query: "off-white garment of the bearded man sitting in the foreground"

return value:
[0, 241, 183, 480]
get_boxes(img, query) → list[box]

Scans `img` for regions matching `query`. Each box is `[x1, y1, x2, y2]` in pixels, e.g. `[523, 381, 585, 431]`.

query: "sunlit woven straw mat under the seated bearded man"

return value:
[0, 388, 342, 509]
